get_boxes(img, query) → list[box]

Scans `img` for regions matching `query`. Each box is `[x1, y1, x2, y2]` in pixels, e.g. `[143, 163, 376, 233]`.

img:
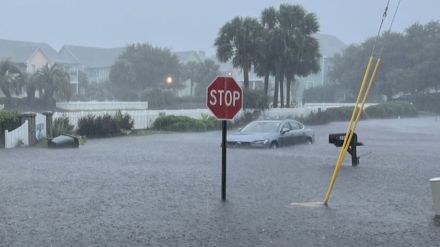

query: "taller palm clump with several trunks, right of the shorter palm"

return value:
[263, 4, 321, 107]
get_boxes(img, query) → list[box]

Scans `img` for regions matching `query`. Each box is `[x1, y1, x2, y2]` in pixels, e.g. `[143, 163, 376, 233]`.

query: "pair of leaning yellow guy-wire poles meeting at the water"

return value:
[324, 56, 381, 205]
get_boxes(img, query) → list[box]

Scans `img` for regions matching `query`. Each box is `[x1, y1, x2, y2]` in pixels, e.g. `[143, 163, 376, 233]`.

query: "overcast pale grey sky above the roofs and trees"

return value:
[0, 0, 440, 54]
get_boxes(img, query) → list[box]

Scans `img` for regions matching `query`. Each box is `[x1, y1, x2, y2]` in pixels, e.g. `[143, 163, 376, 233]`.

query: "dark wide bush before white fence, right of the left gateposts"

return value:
[77, 112, 133, 137]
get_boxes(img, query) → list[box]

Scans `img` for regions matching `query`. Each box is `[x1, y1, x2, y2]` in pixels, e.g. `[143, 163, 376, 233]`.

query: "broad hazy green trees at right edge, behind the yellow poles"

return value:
[330, 21, 440, 99]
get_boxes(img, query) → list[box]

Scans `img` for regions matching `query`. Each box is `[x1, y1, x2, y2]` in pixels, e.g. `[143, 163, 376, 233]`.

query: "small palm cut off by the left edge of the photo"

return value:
[0, 60, 25, 100]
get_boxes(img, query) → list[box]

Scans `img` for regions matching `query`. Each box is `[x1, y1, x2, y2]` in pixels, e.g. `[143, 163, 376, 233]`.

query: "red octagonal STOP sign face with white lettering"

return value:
[206, 76, 243, 120]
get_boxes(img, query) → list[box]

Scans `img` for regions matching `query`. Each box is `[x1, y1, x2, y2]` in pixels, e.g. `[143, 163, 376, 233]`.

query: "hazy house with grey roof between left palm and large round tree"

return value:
[59, 45, 125, 83]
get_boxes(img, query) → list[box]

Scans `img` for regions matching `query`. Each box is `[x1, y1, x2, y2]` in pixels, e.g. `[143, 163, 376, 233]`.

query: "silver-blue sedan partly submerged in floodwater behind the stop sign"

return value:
[227, 119, 315, 148]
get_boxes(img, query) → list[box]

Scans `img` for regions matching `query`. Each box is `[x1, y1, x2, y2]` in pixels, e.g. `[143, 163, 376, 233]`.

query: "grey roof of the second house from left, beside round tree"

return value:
[59, 45, 125, 68]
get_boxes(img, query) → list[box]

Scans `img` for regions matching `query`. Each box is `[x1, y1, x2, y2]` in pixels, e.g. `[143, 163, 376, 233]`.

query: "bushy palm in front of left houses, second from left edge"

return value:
[31, 64, 72, 101]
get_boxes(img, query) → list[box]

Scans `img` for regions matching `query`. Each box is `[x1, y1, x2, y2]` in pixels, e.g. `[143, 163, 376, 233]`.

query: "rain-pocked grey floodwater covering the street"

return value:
[0, 118, 440, 246]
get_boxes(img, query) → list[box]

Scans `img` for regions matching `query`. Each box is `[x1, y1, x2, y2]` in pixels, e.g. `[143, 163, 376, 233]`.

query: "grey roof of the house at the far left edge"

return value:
[0, 39, 61, 63]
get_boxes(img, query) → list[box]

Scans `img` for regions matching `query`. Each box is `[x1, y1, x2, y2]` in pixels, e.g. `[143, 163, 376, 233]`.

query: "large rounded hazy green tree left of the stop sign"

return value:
[110, 44, 181, 100]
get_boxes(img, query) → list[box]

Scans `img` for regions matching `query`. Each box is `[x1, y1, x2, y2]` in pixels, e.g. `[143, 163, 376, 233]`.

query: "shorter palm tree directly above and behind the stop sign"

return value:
[214, 17, 263, 89]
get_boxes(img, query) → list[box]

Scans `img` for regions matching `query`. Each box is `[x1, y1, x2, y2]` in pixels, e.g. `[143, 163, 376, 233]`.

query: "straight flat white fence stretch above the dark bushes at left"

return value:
[56, 101, 148, 111]
